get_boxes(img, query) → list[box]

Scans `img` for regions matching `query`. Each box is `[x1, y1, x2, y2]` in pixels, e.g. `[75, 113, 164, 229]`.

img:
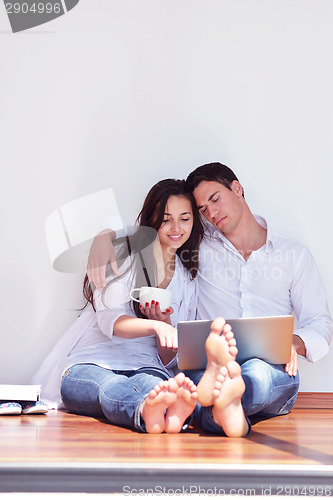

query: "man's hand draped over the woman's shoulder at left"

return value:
[87, 229, 120, 290]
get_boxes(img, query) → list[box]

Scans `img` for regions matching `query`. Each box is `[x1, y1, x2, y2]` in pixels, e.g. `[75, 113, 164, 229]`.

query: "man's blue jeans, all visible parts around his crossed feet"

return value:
[185, 358, 299, 433]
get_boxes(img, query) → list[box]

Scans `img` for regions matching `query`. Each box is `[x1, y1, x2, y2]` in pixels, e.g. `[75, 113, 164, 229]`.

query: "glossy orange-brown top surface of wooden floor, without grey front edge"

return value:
[0, 408, 333, 465]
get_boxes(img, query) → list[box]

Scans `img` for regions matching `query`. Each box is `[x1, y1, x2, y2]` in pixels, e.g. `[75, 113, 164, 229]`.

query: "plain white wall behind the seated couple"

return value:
[0, 0, 333, 391]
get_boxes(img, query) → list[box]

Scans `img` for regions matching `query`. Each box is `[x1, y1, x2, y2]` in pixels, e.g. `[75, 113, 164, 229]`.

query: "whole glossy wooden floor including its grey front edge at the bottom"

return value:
[0, 394, 333, 496]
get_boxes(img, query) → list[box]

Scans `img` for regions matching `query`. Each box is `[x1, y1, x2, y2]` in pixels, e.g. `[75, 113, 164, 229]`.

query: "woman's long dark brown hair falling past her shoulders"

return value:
[83, 179, 204, 318]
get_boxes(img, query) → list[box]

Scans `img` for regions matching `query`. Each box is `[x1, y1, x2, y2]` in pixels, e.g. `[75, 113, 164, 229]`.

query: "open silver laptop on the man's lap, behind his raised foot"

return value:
[178, 315, 294, 370]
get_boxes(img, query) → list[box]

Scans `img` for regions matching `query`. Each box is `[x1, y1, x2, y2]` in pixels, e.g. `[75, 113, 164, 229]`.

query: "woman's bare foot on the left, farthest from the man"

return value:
[140, 374, 178, 434]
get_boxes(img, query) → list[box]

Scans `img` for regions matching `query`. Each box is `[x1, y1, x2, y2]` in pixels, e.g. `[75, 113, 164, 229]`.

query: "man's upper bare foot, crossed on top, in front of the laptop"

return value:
[197, 318, 238, 406]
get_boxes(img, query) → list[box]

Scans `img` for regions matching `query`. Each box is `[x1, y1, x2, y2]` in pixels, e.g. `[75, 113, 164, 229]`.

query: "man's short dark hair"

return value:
[186, 162, 244, 196]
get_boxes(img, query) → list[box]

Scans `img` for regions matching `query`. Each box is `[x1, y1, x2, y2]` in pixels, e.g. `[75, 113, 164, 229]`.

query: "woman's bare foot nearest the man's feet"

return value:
[165, 373, 198, 434]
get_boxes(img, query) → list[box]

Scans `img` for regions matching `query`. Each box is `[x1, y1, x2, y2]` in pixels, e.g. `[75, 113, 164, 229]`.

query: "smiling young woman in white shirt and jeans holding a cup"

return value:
[33, 179, 203, 433]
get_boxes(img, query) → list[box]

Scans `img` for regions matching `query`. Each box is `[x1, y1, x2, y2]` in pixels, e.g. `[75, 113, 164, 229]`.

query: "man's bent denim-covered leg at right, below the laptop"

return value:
[241, 359, 299, 417]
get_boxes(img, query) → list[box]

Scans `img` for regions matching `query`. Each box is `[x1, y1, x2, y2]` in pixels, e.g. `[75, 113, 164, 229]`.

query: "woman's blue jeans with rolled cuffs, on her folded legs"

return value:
[61, 364, 170, 432]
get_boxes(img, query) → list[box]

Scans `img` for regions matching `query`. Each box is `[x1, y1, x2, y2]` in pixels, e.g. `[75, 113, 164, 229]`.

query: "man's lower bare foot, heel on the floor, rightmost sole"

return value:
[212, 361, 249, 437]
